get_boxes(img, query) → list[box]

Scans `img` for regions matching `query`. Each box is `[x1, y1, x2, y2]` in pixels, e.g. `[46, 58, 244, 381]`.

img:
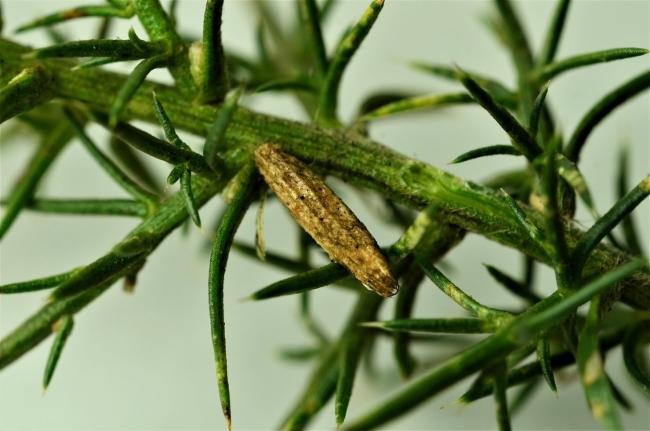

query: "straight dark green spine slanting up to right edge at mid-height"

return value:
[571, 175, 650, 270]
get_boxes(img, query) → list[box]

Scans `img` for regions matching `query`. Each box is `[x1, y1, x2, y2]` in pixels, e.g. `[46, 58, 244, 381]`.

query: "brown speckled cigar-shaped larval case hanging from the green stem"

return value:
[255, 144, 398, 297]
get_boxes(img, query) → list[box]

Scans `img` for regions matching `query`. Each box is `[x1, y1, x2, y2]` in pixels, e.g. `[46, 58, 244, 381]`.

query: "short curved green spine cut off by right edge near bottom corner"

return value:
[623, 319, 650, 397]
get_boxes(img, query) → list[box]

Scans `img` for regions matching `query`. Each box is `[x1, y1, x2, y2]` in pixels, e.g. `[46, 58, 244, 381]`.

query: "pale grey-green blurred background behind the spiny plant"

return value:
[0, 0, 650, 430]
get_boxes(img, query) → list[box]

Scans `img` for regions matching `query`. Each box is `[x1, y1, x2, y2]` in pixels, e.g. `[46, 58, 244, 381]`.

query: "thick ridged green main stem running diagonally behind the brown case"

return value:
[0, 40, 650, 309]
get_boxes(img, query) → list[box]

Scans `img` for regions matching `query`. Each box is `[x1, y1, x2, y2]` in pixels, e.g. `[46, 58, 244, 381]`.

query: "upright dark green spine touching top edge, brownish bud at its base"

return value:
[198, 0, 228, 103]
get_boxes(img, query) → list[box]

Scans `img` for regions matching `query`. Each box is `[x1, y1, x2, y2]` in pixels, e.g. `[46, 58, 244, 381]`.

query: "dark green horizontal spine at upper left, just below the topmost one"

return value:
[24, 39, 161, 61]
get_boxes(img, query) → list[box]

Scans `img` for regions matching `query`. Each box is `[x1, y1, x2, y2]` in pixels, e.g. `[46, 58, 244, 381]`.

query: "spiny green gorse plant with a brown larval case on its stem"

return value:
[0, 0, 650, 430]
